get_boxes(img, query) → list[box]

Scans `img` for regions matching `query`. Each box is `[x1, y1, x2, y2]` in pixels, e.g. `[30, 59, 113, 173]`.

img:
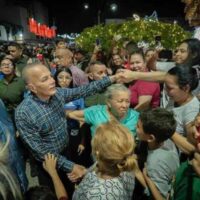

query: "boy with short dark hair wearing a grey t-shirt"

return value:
[137, 108, 179, 199]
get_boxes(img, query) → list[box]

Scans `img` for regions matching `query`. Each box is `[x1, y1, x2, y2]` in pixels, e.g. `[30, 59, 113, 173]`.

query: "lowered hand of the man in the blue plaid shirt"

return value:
[67, 164, 87, 182]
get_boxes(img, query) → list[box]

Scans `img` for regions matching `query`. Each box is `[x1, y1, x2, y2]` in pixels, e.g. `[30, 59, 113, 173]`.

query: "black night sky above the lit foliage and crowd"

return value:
[31, 0, 188, 33]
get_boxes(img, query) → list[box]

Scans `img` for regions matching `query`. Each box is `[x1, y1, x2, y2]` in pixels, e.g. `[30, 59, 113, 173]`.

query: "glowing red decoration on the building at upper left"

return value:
[29, 18, 56, 38]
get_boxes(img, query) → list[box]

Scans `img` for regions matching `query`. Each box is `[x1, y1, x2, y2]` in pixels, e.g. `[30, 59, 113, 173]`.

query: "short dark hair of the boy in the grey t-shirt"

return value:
[140, 108, 176, 143]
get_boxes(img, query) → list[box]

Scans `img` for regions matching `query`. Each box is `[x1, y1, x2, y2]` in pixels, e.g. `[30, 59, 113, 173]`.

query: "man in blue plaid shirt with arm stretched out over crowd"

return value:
[15, 63, 122, 198]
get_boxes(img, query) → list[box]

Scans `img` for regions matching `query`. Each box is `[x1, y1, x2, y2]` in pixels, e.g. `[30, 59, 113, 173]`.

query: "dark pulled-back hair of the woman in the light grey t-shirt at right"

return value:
[168, 64, 199, 91]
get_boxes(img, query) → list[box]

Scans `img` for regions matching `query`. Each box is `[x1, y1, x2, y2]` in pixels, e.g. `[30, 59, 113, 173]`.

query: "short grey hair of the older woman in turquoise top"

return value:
[104, 83, 130, 100]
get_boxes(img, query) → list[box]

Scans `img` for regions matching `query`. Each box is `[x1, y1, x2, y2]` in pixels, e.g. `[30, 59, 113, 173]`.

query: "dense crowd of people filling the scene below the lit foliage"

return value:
[0, 38, 200, 200]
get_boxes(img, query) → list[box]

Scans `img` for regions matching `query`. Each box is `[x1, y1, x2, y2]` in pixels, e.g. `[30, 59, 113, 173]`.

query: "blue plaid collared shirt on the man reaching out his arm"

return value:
[15, 77, 111, 172]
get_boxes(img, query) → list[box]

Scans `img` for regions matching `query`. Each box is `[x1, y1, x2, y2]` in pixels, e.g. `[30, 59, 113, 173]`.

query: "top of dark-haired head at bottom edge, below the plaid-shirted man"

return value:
[24, 186, 57, 200]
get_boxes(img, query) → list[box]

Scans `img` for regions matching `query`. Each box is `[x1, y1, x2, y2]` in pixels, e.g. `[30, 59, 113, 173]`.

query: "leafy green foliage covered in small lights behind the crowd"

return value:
[76, 19, 192, 51]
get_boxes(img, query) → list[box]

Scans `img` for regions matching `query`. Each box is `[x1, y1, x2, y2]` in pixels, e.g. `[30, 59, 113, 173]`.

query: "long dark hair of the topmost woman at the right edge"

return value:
[181, 38, 200, 66]
